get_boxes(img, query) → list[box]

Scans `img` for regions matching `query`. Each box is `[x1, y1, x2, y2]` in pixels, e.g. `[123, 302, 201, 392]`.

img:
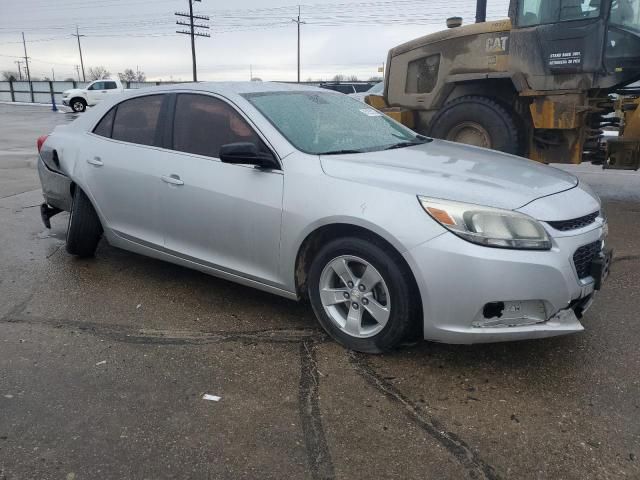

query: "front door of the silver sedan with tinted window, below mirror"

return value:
[160, 93, 283, 283]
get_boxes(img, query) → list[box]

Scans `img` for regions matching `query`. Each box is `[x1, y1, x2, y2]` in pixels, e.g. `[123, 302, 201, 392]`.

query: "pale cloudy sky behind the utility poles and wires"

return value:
[0, 0, 508, 80]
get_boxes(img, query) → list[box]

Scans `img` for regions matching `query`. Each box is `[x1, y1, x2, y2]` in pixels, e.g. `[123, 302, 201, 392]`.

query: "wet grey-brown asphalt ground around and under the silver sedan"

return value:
[0, 105, 640, 480]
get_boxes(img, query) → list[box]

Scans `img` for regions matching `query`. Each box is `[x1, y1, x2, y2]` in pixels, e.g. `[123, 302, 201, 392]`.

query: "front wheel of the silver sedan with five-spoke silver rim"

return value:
[307, 237, 420, 353]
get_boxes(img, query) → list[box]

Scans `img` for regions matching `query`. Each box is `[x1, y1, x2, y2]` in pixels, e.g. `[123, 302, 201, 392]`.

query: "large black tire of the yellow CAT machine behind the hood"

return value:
[429, 96, 522, 155]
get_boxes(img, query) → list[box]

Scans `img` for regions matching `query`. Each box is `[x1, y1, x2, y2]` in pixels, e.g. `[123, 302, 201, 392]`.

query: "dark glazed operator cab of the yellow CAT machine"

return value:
[509, 0, 640, 91]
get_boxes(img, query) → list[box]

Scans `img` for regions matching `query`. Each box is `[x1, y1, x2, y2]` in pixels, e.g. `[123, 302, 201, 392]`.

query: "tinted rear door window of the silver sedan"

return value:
[111, 95, 164, 145]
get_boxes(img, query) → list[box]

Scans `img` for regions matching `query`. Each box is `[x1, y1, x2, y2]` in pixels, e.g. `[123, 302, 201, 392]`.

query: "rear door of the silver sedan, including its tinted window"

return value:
[79, 95, 167, 246]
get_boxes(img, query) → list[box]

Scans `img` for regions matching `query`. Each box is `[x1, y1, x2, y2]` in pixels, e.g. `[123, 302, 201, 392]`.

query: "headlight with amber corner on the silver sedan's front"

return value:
[418, 196, 551, 250]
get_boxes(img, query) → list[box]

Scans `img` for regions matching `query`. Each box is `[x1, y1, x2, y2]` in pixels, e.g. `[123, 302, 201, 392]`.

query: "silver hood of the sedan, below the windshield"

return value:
[320, 140, 578, 210]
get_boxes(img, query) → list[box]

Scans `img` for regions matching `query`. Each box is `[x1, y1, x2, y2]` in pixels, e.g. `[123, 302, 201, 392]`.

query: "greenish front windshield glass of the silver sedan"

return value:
[245, 91, 427, 155]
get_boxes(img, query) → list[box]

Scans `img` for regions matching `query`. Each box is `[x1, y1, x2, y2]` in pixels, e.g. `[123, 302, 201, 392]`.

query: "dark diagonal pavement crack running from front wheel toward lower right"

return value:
[349, 351, 500, 480]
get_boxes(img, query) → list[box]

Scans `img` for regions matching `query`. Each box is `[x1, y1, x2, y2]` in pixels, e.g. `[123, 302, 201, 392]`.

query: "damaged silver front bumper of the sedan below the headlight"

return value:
[404, 225, 604, 343]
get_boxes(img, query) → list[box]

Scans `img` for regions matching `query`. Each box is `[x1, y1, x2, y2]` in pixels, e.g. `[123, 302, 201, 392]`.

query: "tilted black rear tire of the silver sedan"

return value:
[66, 188, 102, 258]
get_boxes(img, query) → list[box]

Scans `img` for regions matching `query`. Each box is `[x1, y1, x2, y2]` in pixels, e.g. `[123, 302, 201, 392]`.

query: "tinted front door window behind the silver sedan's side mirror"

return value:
[173, 93, 268, 158]
